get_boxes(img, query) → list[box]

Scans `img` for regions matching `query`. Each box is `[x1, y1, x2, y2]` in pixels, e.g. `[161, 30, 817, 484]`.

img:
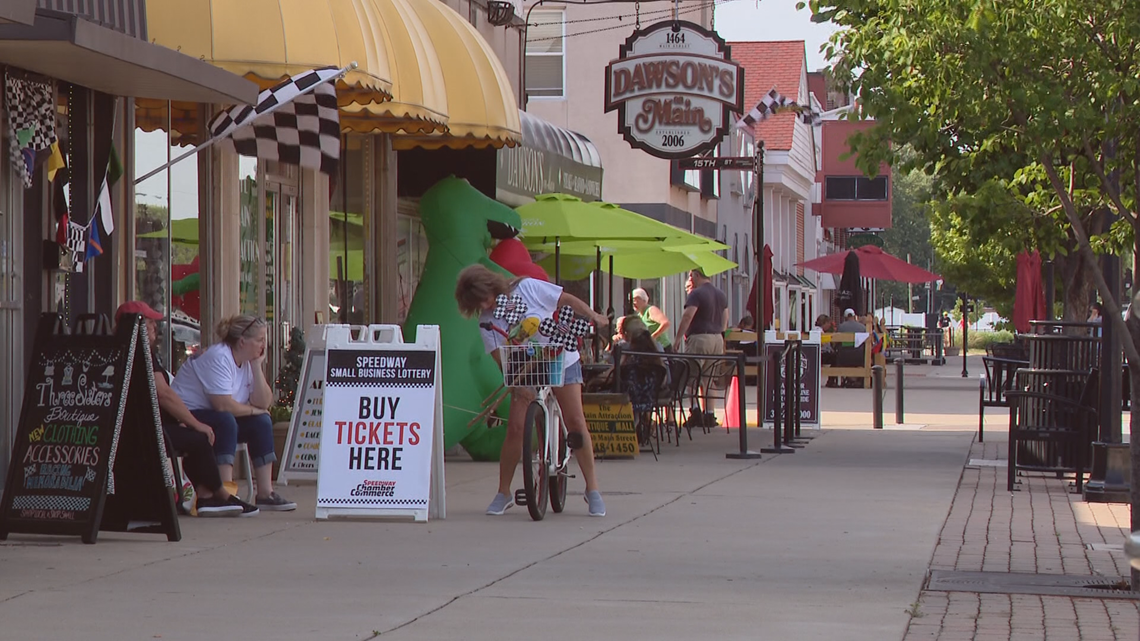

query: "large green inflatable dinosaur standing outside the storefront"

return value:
[404, 177, 522, 461]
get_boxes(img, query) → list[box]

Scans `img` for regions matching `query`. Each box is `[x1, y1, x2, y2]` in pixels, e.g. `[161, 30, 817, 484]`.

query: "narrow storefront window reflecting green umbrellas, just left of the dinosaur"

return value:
[328, 136, 380, 324]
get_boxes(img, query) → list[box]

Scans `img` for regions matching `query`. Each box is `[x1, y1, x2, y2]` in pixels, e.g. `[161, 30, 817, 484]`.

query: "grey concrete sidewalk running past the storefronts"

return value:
[0, 355, 1138, 641]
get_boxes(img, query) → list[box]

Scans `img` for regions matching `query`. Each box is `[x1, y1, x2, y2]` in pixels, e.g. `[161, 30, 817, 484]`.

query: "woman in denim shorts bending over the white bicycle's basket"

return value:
[455, 265, 609, 517]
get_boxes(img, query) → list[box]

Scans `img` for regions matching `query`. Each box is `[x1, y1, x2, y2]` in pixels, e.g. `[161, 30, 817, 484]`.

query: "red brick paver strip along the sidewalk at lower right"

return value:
[904, 432, 1140, 641]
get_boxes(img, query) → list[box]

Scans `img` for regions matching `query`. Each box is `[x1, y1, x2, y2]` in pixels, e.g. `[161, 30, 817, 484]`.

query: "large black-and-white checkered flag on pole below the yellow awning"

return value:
[207, 67, 345, 176]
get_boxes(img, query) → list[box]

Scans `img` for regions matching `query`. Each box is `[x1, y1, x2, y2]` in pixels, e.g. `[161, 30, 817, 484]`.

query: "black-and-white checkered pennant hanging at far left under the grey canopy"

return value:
[5, 74, 56, 189]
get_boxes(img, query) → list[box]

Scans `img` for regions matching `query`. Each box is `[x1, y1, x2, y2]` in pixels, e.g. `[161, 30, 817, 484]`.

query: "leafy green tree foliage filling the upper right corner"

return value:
[807, 0, 1140, 326]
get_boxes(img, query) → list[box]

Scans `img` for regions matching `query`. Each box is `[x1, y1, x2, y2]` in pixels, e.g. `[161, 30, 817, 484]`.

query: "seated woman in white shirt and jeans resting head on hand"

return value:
[170, 315, 296, 511]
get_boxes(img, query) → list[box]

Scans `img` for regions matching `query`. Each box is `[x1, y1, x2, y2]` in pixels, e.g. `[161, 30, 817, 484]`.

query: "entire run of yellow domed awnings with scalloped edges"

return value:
[136, 0, 519, 147]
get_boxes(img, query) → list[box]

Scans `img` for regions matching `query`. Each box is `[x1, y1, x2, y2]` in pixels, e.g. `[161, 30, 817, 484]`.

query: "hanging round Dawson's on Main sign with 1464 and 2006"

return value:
[605, 21, 744, 159]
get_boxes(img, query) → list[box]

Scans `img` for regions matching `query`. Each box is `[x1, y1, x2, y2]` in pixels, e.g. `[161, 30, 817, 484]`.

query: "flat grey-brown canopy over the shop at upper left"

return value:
[0, 9, 258, 104]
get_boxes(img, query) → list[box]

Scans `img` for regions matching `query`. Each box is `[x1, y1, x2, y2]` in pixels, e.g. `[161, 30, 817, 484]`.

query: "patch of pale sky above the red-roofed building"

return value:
[715, 0, 837, 71]
